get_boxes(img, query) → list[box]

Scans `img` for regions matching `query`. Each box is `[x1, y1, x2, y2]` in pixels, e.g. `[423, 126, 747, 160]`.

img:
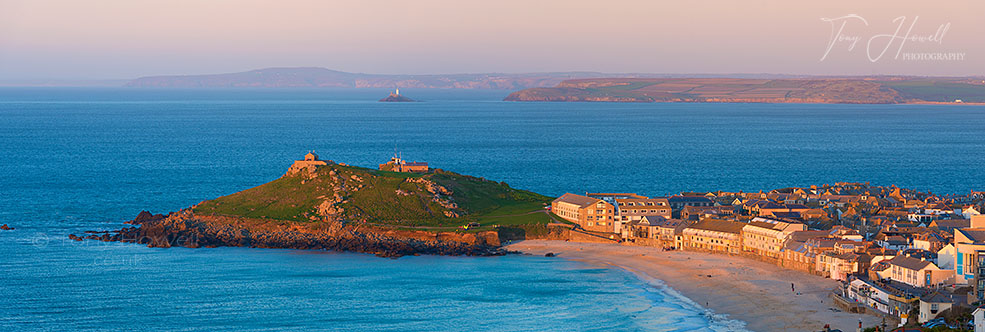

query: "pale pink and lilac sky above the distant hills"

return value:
[0, 0, 985, 81]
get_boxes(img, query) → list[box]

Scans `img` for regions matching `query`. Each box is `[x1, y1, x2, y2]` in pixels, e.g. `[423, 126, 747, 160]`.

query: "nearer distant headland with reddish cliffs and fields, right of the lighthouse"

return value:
[505, 77, 985, 104]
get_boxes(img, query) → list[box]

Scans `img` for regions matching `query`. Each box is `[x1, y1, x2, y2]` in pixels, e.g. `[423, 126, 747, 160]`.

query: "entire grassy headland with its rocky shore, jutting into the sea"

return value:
[70, 153, 550, 257]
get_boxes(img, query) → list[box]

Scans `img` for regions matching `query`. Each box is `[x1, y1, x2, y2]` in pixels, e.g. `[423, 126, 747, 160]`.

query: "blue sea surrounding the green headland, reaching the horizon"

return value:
[0, 88, 985, 331]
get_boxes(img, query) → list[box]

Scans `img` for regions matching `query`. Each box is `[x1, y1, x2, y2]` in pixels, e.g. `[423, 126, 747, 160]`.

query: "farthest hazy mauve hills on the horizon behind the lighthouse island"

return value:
[119, 67, 620, 90]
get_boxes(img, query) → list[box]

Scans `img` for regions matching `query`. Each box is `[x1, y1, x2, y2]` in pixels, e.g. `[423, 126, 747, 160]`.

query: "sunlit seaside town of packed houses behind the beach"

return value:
[549, 182, 985, 332]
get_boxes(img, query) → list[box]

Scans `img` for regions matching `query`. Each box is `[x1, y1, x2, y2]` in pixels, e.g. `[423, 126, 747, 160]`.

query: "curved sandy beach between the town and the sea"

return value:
[507, 240, 882, 332]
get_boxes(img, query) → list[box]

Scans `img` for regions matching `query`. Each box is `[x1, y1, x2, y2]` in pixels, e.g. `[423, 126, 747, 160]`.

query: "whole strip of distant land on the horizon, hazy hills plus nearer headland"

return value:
[124, 67, 985, 103]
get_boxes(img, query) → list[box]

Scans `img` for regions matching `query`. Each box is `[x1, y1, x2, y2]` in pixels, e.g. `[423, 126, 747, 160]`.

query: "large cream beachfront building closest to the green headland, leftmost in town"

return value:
[551, 193, 615, 233]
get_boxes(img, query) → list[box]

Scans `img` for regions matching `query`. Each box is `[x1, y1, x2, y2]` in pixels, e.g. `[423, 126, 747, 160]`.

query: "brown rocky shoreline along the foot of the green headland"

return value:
[69, 210, 515, 258]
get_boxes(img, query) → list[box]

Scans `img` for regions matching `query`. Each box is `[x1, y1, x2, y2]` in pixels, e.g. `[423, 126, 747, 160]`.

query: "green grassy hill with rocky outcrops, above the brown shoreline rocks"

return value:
[193, 163, 551, 228]
